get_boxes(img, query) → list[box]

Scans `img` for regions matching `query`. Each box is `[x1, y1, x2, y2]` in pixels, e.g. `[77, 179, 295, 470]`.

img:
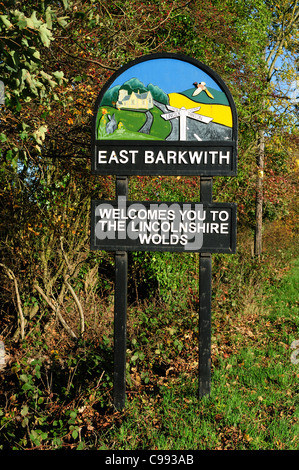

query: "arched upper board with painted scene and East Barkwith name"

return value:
[92, 53, 237, 176]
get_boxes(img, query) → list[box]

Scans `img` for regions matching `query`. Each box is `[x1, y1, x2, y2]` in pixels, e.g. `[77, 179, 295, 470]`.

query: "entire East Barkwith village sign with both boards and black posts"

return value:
[91, 54, 237, 409]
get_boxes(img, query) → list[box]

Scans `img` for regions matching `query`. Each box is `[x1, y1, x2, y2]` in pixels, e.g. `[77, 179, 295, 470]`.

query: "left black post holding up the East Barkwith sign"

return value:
[113, 176, 128, 410]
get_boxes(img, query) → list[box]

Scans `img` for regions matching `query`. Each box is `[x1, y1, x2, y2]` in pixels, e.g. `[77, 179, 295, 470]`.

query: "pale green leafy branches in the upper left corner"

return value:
[0, 5, 65, 164]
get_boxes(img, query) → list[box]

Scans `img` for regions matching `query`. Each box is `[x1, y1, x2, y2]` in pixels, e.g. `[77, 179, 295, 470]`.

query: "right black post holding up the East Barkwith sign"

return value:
[198, 177, 213, 398]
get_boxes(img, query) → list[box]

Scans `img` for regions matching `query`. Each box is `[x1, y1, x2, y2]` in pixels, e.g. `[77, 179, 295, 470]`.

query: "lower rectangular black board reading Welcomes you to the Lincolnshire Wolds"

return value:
[91, 197, 237, 253]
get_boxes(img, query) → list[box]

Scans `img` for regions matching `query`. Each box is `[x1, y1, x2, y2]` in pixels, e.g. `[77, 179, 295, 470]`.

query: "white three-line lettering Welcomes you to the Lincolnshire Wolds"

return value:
[94, 202, 230, 251]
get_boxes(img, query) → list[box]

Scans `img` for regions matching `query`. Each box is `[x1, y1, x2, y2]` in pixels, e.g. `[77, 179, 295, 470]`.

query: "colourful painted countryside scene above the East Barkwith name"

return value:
[96, 58, 233, 141]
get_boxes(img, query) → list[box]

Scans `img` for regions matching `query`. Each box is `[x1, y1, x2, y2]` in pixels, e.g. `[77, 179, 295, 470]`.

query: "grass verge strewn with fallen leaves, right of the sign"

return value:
[92, 262, 299, 450]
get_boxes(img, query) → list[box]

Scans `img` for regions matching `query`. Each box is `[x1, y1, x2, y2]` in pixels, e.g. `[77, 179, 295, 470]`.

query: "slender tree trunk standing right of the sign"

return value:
[254, 130, 265, 257]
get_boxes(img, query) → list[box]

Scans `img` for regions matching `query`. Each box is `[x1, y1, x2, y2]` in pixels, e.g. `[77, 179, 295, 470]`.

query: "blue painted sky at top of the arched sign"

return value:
[110, 58, 222, 94]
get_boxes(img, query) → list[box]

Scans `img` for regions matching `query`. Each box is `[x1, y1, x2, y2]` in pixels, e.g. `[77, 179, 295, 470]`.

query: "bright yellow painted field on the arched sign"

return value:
[168, 93, 233, 127]
